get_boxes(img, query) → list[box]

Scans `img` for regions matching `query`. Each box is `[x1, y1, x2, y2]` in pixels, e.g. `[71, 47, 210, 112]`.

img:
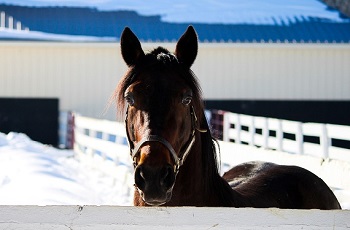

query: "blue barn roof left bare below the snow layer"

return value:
[0, 0, 350, 43]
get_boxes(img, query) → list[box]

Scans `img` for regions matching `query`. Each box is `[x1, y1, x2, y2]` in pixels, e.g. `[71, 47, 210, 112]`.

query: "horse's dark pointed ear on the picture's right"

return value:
[175, 26, 198, 68]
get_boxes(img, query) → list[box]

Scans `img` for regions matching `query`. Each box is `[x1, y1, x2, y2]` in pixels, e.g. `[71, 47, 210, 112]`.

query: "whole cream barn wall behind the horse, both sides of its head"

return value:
[0, 42, 350, 119]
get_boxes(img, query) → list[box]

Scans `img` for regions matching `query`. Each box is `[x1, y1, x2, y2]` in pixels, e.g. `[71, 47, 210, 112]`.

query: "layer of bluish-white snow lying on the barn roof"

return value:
[0, 0, 349, 25]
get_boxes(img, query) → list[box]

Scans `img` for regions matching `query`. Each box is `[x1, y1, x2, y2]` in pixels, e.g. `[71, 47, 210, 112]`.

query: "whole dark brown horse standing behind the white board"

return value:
[116, 26, 340, 209]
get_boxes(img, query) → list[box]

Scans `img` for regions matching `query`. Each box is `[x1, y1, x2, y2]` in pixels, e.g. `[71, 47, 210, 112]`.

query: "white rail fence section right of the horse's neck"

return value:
[223, 112, 350, 161]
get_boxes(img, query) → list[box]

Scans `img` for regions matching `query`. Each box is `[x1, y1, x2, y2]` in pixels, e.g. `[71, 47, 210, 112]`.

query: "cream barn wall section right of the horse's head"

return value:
[193, 44, 350, 100]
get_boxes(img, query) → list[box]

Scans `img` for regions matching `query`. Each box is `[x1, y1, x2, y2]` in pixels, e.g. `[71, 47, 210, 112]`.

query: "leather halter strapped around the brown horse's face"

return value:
[125, 106, 207, 175]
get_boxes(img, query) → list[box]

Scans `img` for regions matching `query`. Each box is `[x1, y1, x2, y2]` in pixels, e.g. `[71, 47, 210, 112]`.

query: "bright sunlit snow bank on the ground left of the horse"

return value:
[0, 133, 132, 206]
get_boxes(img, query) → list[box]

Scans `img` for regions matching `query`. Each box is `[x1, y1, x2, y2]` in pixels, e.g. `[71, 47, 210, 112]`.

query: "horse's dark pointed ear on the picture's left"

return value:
[120, 27, 145, 66]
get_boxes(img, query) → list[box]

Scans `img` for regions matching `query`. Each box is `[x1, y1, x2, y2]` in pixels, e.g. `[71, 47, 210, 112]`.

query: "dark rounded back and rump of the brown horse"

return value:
[223, 161, 340, 209]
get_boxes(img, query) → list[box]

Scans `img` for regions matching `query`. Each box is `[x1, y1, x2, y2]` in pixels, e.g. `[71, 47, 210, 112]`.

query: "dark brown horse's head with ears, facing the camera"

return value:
[117, 26, 201, 205]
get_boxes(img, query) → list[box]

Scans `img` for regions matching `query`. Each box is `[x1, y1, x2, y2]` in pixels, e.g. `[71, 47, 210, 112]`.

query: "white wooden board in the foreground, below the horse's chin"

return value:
[0, 206, 350, 230]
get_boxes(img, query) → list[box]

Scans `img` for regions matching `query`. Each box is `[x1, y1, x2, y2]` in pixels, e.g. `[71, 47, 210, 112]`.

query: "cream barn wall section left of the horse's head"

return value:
[0, 43, 126, 119]
